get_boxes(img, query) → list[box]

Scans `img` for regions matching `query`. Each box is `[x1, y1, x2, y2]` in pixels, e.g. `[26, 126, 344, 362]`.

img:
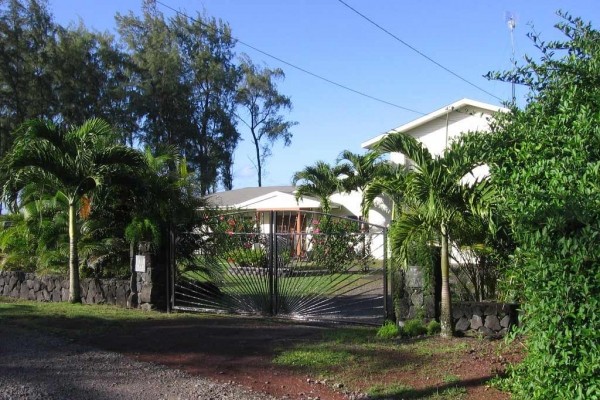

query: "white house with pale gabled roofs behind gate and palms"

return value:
[206, 99, 508, 258]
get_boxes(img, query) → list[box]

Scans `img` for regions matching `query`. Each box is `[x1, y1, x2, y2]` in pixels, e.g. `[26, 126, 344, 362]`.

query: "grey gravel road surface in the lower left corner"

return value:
[0, 326, 273, 400]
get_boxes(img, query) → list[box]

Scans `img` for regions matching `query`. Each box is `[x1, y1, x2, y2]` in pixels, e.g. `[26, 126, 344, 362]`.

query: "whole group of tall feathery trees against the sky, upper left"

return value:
[0, 0, 293, 195]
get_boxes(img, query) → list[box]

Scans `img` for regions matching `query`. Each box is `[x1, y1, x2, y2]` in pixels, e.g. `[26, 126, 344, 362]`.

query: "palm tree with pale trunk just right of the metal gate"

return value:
[367, 133, 493, 337]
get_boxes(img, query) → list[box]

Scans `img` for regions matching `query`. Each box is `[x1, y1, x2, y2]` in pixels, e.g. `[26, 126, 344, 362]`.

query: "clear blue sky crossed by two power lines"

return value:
[50, 0, 600, 188]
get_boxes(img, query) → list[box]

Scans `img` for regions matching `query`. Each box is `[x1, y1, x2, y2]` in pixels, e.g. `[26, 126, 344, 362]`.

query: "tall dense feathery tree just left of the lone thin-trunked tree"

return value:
[116, 3, 240, 195]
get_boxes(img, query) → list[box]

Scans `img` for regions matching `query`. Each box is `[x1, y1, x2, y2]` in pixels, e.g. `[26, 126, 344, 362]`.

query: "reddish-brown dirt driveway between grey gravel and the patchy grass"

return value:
[54, 317, 347, 400]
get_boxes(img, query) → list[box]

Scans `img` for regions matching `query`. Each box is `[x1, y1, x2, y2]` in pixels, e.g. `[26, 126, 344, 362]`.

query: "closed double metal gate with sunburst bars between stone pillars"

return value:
[171, 211, 390, 324]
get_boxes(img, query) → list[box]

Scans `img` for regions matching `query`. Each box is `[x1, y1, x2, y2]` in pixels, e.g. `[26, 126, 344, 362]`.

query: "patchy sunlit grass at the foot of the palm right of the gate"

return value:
[274, 327, 482, 399]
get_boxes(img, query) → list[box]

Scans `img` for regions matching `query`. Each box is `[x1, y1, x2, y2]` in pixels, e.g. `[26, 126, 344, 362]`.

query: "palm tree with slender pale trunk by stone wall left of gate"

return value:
[2, 119, 144, 303]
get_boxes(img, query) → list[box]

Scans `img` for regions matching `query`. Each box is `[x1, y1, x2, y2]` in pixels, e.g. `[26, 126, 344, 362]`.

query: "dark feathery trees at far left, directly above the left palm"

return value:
[0, 0, 137, 151]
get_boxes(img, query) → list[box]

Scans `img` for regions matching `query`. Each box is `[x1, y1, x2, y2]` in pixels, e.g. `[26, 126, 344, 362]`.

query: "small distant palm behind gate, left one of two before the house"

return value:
[292, 161, 351, 214]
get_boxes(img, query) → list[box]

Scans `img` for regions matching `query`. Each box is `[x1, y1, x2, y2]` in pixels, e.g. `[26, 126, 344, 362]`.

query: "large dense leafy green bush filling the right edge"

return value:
[476, 14, 600, 399]
